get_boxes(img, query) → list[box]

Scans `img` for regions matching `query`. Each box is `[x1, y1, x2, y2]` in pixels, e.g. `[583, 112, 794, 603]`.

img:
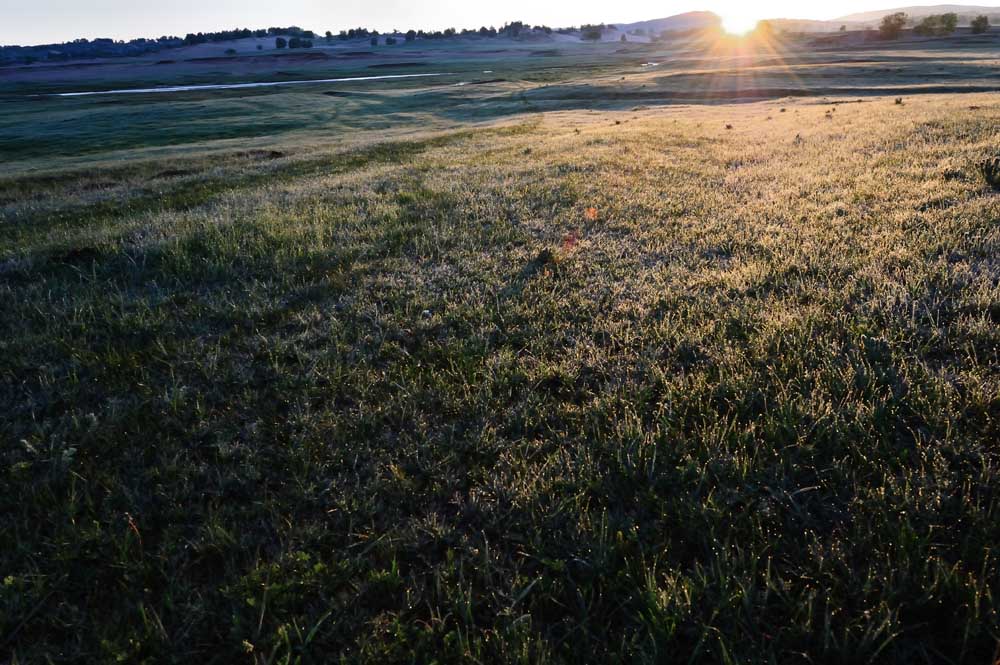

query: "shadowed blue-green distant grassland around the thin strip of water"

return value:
[0, 31, 1000, 174]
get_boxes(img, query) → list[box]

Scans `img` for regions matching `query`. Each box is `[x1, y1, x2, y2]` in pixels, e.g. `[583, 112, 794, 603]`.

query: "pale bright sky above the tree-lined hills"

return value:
[0, 0, 968, 44]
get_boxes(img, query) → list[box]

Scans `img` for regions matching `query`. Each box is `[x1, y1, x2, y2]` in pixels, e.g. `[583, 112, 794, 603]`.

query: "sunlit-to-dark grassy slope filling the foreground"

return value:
[0, 97, 1000, 665]
